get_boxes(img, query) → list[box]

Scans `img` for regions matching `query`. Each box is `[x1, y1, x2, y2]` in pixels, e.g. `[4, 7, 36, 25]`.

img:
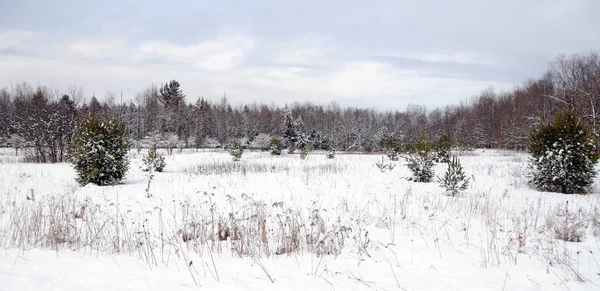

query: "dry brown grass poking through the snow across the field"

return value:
[0, 149, 600, 286]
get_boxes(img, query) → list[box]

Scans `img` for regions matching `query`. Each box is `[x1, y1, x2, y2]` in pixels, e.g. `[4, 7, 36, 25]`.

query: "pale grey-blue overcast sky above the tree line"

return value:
[0, 0, 600, 109]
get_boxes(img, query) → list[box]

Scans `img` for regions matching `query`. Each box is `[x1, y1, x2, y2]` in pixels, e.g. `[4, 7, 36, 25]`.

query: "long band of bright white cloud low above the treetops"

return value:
[0, 31, 512, 108]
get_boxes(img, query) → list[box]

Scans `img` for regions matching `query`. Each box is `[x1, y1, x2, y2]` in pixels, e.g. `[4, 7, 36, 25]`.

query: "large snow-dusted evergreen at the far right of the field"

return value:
[529, 108, 598, 194]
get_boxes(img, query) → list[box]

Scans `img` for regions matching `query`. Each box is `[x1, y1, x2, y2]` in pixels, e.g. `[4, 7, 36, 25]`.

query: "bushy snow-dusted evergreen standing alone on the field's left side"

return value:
[69, 113, 131, 185]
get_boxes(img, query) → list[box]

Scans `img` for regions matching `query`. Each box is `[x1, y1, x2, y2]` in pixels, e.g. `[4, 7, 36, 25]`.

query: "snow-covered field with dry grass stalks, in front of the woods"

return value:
[0, 149, 600, 291]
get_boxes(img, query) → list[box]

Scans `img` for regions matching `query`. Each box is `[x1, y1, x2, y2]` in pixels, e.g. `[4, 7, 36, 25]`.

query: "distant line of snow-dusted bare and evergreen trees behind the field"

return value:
[0, 52, 600, 162]
